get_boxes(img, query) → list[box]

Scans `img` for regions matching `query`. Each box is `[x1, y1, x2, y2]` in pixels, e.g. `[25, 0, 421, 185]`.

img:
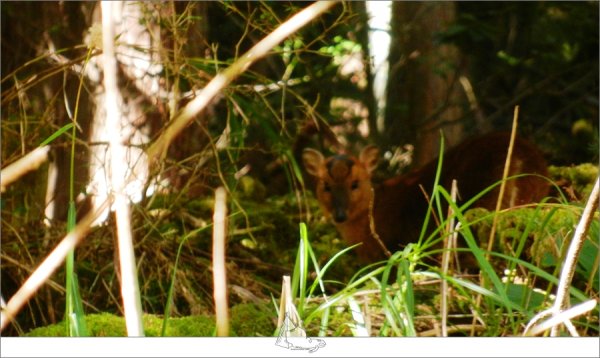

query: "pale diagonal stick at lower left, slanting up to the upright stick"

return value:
[0, 201, 108, 330]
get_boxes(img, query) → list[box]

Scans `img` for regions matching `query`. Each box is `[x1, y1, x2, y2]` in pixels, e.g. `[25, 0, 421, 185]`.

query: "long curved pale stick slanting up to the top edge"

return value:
[148, 1, 337, 164]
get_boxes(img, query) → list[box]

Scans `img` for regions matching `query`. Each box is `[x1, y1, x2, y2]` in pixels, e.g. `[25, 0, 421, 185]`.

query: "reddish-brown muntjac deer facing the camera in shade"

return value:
[302, 133, 549, 262]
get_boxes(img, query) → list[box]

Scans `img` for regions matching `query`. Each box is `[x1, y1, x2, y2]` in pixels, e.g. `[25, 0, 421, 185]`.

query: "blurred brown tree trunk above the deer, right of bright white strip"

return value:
[385, 1, 463, 166]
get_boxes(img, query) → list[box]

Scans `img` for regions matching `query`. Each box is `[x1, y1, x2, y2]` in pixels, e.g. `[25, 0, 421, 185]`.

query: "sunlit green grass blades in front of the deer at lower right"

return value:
[293, 153, 599, 337]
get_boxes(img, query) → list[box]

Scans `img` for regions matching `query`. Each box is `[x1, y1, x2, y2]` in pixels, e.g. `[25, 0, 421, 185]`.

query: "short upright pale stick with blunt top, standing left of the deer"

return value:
[213, 187, 229, 337]
